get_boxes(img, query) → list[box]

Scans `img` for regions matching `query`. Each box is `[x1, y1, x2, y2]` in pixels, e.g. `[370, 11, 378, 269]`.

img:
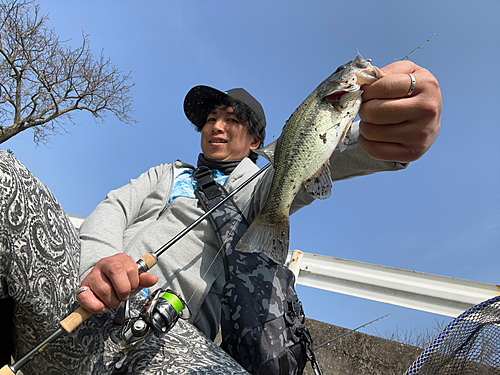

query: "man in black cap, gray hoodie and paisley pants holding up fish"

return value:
[0, 61, 441, 374]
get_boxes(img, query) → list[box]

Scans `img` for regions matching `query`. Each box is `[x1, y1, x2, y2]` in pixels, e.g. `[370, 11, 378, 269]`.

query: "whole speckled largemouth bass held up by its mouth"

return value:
[236, 56, 380, 263]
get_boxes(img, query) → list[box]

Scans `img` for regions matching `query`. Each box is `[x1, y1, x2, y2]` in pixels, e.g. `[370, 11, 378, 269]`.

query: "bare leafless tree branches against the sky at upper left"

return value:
[0, 0, 135, 144]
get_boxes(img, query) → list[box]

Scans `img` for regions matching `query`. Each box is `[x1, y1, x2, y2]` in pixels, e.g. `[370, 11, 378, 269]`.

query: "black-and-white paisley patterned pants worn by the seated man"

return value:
[0, 151, 247, 375]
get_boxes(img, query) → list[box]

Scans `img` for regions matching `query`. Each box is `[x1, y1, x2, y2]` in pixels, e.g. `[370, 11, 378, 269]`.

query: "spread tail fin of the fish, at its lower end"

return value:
[235, 215, 290, 264]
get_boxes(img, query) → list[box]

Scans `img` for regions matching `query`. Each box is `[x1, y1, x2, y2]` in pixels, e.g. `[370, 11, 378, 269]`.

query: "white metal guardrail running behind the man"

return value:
[69, 215, 500, 317]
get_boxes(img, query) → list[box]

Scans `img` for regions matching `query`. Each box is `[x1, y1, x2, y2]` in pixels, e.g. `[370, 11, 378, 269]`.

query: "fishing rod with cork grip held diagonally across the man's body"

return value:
[0, 163, 271, 375]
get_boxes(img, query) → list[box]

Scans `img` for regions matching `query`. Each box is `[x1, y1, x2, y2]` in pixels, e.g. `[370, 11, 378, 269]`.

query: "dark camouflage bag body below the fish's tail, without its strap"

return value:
[221, 251, 305, 374]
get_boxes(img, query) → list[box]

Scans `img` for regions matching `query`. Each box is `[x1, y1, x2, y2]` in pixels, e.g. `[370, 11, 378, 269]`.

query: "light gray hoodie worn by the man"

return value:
[80, 123, 406, 339]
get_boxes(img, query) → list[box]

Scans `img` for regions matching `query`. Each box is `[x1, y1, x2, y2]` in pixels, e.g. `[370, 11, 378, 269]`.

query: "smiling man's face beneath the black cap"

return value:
[201, 107, 260, 161]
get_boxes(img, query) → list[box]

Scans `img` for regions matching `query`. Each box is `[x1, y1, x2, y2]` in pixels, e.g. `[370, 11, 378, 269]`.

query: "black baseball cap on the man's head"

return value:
[184, 86, 266, 141]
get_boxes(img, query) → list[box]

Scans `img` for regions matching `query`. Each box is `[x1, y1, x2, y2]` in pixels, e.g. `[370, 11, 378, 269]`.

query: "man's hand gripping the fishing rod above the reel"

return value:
[78, 253, 158, 314]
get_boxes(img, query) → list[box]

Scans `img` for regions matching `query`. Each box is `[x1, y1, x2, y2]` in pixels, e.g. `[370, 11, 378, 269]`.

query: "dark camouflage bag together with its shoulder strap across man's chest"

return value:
[194, 168, 312, 375]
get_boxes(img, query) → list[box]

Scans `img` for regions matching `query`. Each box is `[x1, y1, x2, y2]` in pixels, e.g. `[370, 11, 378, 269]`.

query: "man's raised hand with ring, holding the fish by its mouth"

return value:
[358, 61, 442, 163]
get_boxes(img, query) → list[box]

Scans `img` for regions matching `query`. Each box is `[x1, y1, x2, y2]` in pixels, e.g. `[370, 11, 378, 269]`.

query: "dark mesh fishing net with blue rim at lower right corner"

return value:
[405, 296, 500, 375]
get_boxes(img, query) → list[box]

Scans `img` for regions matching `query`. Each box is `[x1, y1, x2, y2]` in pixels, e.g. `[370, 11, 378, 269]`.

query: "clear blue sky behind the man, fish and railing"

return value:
[0, 0, 500, 346]
